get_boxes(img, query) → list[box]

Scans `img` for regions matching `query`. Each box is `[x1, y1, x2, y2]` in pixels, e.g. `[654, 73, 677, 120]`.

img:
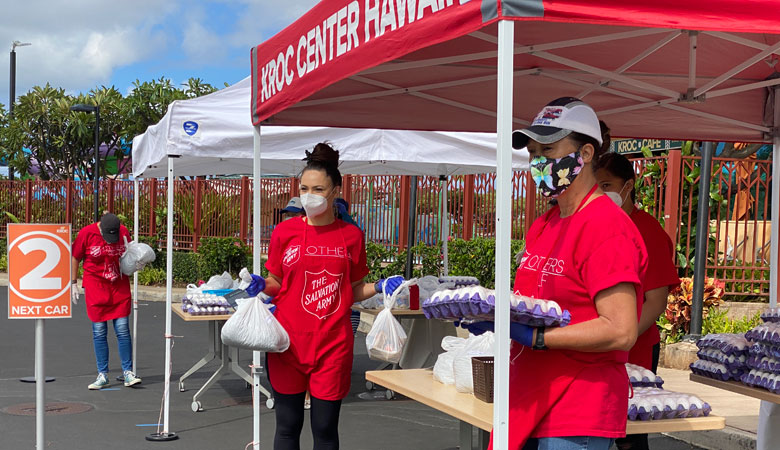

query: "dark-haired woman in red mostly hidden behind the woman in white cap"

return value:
[594, 153, 680, 450]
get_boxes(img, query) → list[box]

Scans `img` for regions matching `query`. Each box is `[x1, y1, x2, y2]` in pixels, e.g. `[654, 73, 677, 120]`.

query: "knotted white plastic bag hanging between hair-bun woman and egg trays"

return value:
[366, 279, 416, 364]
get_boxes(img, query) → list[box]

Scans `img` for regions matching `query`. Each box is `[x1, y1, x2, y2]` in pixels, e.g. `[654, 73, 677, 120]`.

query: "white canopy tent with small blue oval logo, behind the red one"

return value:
[133, 78, 528, 440]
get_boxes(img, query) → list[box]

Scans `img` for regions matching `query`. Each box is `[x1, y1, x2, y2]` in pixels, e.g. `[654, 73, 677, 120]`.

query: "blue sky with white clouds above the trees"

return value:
[0, 0, 317, 109]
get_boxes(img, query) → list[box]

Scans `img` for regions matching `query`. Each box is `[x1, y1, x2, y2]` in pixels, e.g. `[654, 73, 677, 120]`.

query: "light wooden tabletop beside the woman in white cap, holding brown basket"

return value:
[366, 369, 726, 434]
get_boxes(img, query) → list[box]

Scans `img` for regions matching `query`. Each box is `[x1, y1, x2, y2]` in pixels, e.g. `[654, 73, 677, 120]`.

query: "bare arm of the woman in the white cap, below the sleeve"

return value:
[544, 283, 637, 352]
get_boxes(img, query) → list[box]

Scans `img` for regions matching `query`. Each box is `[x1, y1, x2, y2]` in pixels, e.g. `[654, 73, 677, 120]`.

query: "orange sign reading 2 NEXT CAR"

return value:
[8, 223, 71, 319]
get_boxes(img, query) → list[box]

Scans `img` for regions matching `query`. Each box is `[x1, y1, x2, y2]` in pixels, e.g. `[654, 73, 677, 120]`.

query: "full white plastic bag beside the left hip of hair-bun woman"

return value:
[222, 298, 290, 353]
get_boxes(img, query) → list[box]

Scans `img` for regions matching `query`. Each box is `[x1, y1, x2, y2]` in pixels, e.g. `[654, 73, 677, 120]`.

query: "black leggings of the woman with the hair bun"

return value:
[274, 392, 341, 450]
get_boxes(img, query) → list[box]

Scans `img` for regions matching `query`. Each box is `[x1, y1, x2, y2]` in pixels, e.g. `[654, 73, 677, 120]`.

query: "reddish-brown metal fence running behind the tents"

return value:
[0, 151, 772, 297]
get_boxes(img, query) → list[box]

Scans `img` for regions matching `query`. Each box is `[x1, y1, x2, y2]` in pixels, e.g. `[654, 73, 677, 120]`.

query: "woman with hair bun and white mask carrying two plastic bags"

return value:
[263, 144, 403, 450]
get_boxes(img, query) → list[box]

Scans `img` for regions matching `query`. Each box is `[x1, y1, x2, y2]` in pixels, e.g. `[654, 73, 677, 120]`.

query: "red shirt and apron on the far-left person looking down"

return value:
[73, 223, 132, 322]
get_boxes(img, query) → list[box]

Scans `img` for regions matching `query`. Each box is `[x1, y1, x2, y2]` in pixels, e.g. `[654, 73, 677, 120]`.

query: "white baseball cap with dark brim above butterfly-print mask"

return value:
[512, 97, 603, 149]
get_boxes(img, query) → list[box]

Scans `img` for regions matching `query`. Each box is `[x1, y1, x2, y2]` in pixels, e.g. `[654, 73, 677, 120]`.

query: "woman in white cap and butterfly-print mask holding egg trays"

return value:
[472, 97, 646, 450]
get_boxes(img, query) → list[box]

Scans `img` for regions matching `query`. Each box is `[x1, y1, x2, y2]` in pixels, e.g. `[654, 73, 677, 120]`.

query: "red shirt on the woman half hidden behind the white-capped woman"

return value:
[628, 208, 680, 370]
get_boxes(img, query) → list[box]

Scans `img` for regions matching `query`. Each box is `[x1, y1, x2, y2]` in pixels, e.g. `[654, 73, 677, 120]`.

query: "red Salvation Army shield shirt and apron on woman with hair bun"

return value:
[265, 217, 368, 400]
